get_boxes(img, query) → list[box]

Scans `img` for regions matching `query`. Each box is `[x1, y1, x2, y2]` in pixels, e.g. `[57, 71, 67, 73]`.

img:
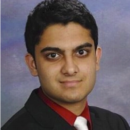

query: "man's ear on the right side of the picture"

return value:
[96, 47, 102, 71]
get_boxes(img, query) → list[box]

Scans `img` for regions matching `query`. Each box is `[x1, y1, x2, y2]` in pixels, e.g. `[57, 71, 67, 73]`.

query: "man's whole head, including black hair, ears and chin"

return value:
[25, 0, 101, 109]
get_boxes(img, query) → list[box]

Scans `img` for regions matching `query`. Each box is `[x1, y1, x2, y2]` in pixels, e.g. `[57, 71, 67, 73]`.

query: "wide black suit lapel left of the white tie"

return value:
[25, 91, 73, 130]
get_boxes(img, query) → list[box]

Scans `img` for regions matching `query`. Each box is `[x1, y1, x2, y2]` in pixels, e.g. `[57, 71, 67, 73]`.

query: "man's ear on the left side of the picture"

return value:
[25, 53, 38, 76]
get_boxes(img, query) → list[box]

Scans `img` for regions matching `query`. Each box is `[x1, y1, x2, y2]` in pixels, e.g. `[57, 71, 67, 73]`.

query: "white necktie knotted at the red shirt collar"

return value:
[74, 116, 88, 130]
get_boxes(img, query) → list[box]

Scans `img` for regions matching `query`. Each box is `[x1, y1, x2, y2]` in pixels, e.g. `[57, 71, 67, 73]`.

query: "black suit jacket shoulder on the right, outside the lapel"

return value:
[89, 106, 130, 130]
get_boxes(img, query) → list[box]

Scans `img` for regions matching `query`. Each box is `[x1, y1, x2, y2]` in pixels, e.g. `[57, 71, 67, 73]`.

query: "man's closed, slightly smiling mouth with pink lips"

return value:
[60, 80, 81, 88]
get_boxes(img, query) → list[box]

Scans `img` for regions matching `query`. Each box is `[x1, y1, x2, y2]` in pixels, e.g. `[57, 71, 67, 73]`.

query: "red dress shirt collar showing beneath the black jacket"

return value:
[38, 88, 92, 130]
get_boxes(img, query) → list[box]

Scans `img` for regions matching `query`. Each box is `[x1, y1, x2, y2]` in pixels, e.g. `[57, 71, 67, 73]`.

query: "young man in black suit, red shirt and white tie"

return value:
[2, 0, 130, 130]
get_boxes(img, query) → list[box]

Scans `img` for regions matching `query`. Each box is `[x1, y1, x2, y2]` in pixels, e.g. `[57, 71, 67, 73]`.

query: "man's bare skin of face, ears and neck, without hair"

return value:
[25, 22, 101, 115]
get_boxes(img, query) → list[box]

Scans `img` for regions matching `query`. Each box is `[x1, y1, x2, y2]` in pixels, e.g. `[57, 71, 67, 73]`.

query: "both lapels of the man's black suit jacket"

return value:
[25, 90, 108, 130]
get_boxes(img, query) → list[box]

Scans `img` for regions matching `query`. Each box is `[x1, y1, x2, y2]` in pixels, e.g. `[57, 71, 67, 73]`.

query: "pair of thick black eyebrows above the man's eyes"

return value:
[41, 43, 92, 53]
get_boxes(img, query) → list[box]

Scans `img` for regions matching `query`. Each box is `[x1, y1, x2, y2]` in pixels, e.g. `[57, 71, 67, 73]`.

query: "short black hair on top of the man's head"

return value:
[25, 0, 98, 57]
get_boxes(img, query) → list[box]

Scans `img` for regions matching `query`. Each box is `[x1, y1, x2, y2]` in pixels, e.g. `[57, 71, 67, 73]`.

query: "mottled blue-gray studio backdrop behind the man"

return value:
[1, 0, 130, 124]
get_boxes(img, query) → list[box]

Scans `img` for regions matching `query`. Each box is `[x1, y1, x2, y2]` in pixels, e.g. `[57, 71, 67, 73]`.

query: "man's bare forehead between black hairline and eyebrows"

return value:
[38, 22, 94, 49]
